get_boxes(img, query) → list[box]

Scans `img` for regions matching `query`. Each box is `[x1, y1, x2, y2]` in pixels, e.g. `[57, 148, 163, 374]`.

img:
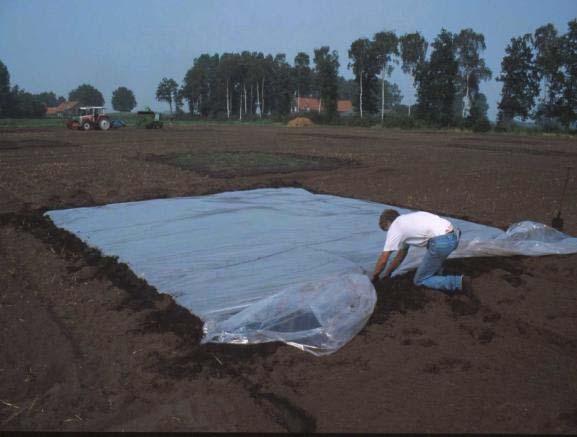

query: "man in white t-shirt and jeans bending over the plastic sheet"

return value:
[373, 209, 471, 294]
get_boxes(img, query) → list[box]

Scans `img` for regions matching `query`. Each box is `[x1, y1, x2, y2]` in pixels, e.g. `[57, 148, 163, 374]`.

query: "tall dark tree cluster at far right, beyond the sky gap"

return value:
[497, 20, 577, 128]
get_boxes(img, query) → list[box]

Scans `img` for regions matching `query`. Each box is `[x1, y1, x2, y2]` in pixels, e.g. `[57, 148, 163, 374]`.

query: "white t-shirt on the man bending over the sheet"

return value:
[383, 211, 453, 252]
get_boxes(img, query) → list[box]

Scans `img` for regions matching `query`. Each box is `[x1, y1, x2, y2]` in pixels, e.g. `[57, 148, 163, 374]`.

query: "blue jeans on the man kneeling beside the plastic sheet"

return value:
[413, 229, 463, 294]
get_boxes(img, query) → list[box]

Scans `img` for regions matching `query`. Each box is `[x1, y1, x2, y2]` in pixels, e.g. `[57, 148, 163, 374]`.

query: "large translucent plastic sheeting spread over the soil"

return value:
[47, 188, 577, 355]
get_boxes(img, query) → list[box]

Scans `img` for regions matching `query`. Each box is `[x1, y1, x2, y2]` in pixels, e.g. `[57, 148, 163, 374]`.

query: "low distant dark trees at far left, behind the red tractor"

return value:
[0, 61, 136, 118]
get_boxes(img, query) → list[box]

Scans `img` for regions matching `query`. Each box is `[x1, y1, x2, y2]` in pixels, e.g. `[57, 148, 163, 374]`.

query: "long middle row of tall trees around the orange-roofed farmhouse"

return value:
[156, 29, 491, 125]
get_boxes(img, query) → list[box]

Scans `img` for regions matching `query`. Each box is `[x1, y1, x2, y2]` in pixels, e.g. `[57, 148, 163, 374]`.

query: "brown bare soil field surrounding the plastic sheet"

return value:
[0, 125, 577, 433]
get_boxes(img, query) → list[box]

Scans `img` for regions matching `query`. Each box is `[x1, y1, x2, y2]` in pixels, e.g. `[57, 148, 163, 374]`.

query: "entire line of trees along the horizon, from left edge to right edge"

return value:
[0, 20, 577, 127]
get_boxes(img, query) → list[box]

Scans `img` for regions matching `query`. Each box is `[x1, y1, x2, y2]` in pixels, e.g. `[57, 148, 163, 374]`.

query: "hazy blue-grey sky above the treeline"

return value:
[0, 0, 577, 118]
